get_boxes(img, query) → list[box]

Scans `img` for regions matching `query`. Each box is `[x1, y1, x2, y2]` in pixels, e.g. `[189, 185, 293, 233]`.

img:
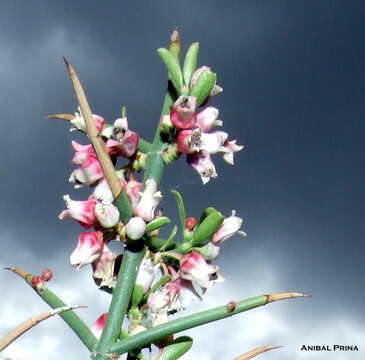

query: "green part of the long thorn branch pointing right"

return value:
[107, 295, 268, 355]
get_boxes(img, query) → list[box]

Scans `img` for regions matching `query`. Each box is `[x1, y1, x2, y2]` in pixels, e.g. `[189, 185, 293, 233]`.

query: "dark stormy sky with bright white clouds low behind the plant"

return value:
[0, 0, 365, 360]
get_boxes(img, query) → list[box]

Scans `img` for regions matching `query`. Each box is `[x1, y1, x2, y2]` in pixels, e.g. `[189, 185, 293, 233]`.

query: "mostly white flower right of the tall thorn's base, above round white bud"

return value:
[134, 179, 162, 222]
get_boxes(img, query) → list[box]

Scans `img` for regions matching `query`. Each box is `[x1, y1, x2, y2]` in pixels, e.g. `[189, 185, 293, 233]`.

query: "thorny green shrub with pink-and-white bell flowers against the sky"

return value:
[1, 31, 303, 360]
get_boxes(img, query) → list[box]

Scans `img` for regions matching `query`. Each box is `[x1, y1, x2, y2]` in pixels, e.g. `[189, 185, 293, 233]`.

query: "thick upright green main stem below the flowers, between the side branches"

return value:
[95, 246, 144, 359]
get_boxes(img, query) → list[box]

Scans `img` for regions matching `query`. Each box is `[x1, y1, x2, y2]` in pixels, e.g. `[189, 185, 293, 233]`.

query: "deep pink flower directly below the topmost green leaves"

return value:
[170, 95, 196, 129]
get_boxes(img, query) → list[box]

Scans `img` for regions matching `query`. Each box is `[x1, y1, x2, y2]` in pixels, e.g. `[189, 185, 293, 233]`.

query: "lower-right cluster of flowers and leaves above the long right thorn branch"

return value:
[93, 202, 245, 336]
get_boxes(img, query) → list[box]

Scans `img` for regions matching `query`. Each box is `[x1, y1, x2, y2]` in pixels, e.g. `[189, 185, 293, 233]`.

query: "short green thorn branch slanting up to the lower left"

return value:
[9, 268, 97, 351]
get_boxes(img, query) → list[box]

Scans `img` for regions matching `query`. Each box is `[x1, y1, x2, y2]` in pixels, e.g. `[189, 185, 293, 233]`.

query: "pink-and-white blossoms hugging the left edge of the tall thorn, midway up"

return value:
[69, 141, 104, 187]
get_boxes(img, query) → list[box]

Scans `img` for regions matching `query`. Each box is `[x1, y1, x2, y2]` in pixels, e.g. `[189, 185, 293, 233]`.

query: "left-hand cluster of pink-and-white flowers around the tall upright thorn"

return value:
[59, 113, 162, 288]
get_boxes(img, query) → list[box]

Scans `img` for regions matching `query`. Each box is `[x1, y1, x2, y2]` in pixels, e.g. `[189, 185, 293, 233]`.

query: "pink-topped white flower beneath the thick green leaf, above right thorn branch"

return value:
[180, 251, 218, 289]
